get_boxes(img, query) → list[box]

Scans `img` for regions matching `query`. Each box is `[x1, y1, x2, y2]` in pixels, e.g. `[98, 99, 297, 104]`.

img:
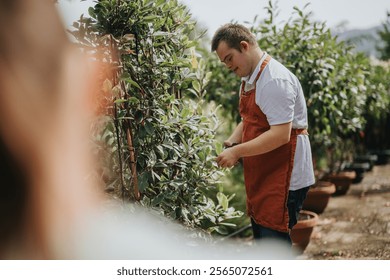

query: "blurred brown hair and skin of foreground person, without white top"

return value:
[0, 0, 103, 259]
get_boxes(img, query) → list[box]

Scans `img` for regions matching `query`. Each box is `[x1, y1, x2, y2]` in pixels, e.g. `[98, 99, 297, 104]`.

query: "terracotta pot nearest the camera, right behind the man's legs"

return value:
[290, 210, 318, 253]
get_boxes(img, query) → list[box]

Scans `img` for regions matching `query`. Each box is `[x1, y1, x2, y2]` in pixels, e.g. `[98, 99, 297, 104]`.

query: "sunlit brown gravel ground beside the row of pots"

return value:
[300, 164, 390, 260]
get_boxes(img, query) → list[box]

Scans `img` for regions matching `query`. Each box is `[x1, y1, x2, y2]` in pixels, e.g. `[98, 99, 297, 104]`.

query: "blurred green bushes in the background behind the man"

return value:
[204, 1, 388, 174]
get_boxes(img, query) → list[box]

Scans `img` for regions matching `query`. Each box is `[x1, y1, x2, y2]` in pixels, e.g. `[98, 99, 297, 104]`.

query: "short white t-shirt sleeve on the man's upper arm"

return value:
[256, 79, 297, 125]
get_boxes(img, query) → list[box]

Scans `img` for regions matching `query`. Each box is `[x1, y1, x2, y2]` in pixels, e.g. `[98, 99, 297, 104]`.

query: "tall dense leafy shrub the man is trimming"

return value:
[72, 0, 242, 233]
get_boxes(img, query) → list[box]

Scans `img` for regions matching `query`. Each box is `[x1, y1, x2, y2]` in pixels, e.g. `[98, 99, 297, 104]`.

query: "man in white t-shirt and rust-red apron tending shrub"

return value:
[212, 24, 315, 244]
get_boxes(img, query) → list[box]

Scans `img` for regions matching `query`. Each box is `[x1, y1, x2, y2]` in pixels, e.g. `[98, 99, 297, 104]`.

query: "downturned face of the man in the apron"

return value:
[216, 41, 251, 77]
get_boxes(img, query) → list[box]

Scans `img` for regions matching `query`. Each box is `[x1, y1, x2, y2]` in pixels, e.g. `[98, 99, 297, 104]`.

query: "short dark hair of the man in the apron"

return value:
[211, 23, 257, 51]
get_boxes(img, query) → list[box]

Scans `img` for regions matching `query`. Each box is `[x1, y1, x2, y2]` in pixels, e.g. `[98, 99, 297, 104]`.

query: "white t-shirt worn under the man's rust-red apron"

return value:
[242, 52, 315, 190]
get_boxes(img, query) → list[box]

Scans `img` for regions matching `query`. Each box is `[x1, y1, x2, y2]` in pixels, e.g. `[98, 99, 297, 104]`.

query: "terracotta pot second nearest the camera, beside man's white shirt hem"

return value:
[302, 181, 336, 214]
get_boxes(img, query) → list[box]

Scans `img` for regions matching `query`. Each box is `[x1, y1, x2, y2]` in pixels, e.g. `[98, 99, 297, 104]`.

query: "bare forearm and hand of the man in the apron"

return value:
[217, 122, 292, 167]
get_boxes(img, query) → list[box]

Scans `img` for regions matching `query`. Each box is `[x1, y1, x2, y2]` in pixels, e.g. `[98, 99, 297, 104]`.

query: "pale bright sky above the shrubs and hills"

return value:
[59, 0, 390, 36]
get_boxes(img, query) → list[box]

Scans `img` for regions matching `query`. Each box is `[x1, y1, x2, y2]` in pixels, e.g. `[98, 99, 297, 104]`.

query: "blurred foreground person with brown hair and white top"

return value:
[0, 0, 290, 259]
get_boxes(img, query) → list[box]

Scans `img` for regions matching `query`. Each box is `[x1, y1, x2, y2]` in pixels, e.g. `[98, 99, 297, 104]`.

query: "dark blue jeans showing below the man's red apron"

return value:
[251, 187, 309, 245]
